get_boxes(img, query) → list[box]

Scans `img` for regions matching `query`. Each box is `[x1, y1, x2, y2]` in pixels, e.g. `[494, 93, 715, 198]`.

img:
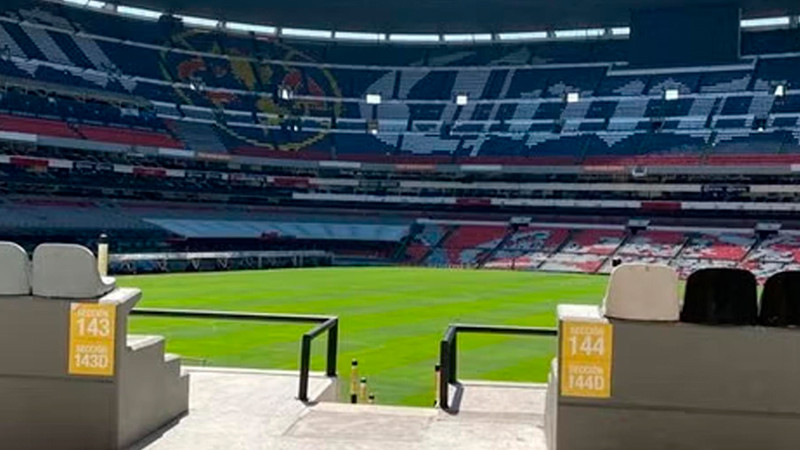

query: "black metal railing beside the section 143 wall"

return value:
[131, 308, 339, 402]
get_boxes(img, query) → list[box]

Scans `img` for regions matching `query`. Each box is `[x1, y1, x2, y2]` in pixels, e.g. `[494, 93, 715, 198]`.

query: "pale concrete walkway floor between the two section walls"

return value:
[135, 368, 545, 450]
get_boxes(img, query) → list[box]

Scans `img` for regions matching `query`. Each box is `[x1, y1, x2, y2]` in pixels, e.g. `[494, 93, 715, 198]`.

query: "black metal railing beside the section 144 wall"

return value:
[439, 324, 558, 411]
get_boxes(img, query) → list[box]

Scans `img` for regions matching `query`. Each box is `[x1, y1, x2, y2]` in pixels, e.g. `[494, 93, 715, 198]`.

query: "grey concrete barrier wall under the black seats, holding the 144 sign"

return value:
[555, 307, 800, 450]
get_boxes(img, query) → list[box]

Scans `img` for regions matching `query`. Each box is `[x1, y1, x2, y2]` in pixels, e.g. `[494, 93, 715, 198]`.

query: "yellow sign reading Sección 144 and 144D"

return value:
[561, 321, 614, 398]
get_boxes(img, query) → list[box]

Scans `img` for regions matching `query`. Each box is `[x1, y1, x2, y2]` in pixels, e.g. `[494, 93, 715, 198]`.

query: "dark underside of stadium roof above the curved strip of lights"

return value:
[114, 0, 800, 33]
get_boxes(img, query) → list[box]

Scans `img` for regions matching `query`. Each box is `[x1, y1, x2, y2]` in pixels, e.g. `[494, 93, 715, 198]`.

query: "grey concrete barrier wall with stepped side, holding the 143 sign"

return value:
[0, 289, 188, 450]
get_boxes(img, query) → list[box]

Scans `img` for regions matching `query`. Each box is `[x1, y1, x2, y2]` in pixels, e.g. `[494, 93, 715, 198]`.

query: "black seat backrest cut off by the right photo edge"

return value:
[758, 271, 800, 327]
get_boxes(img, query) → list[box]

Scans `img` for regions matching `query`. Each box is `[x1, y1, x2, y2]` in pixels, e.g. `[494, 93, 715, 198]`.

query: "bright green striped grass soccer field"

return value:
[119, 268, 606, 406]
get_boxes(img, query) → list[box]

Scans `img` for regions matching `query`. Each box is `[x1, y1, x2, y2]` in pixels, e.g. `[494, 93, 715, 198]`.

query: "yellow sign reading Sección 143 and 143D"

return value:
[69, 303, 117, 376]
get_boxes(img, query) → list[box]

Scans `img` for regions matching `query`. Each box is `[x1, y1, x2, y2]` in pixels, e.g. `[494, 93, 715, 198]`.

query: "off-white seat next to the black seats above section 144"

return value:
[603, 264, 681, 322]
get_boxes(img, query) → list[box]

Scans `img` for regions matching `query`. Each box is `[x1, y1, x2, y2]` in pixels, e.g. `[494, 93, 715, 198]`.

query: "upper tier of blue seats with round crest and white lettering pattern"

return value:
[0, 1, 800, 165]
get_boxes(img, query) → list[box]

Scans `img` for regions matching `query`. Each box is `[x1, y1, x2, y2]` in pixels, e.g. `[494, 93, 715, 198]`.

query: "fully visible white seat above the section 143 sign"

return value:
[32, 244, 116, 299]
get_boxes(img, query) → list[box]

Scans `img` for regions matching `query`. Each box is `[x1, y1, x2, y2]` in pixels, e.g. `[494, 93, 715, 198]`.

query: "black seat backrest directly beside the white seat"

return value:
[681, 268, 758, 325]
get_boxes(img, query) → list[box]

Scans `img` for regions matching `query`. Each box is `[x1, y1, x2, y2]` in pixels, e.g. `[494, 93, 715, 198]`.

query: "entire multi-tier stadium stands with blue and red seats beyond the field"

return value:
[0, 2, 800, 282]
